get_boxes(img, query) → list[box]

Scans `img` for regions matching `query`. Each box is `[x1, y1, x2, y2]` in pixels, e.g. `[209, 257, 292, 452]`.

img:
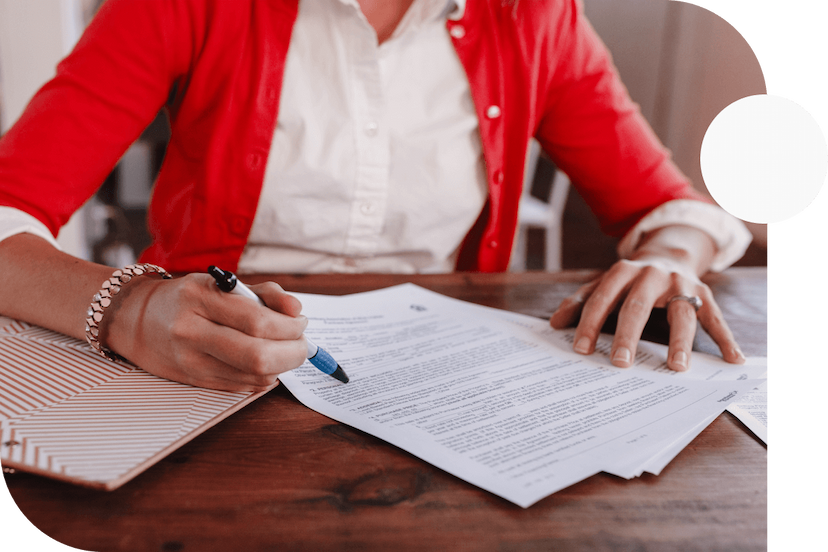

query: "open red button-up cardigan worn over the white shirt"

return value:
[0, 0, 700, 271]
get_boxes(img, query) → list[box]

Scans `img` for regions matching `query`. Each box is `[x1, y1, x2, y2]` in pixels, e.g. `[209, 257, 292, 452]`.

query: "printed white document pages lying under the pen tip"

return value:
[280, 284, 768, 507]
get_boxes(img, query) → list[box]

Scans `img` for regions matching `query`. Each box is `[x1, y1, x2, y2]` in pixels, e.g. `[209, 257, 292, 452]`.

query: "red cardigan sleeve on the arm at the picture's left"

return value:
[0, 0, 181, 235]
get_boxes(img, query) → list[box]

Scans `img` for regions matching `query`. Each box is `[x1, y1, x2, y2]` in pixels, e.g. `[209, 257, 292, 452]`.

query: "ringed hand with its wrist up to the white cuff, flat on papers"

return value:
[549, 227, 745, 371]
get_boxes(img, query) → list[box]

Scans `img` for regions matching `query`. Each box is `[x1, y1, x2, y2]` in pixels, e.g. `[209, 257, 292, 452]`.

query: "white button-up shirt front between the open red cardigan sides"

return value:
[239, 0, 488, 273]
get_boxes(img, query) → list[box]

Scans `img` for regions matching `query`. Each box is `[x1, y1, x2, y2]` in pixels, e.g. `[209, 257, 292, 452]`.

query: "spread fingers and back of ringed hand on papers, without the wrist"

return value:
[549, 261, 745, 371]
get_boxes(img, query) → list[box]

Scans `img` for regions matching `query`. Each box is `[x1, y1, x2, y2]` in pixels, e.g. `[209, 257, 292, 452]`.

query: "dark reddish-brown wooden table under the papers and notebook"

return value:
[3, 268, 770, 552]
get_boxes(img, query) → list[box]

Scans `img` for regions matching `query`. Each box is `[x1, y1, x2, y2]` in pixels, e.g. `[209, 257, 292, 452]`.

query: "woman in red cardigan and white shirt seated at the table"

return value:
[0, 0, 750, 390]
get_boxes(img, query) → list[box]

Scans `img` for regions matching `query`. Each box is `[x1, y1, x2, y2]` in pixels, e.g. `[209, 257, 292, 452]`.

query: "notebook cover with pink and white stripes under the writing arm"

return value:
[0, 316, 263, 490]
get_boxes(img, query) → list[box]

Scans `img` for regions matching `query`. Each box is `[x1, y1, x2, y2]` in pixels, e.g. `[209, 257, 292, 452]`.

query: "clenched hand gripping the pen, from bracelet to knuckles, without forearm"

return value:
[104, 274, 307, 391]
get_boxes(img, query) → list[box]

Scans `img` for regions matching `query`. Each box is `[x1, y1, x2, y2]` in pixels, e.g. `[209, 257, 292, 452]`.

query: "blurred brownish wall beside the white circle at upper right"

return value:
[583, 0, 770, 247]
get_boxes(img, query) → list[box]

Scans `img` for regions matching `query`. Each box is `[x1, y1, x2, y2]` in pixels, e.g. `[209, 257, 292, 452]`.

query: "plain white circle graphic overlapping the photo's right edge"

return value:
[699, 93, 828, 226]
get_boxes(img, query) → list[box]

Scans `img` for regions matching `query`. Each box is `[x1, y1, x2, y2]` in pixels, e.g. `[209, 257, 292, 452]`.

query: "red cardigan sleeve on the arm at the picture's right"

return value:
[536, 1, 702, 236]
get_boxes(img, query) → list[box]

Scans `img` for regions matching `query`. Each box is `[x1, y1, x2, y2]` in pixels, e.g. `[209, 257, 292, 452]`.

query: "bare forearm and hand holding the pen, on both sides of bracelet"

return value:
[0, 233, 307, 391]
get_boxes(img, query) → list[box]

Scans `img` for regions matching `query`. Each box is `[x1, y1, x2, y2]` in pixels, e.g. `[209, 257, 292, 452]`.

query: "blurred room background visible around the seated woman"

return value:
[0, 0, 770, 270]
